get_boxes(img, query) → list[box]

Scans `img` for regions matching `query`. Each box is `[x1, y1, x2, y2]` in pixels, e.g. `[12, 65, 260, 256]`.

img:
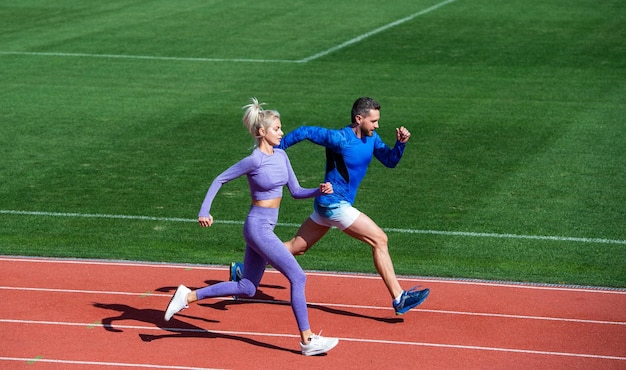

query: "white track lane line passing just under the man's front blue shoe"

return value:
[0, 286, 626, 325]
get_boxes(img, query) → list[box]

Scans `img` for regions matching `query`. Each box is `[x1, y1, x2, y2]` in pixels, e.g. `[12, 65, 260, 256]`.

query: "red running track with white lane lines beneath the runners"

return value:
[0, 256, 626, 370]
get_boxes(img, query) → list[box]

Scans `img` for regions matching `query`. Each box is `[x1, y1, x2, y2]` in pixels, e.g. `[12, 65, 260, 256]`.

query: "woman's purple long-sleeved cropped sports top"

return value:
[198, 148, 322, 217]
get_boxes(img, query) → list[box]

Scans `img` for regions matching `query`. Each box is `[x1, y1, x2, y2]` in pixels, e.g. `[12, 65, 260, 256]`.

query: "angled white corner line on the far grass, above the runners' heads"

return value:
[0, 0, 456, 63]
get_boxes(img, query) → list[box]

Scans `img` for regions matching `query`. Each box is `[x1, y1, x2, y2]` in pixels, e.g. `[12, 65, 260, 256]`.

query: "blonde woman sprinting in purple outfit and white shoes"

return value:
[165, 98, 339, 356]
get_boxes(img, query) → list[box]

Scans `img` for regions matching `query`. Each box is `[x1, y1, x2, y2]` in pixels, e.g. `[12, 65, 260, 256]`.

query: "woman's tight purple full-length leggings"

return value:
[196, 206, 310, 331]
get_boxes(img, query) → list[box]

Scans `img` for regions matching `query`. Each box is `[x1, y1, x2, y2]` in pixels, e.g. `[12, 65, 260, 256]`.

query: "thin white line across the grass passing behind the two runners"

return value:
[0, 209, 626, 245]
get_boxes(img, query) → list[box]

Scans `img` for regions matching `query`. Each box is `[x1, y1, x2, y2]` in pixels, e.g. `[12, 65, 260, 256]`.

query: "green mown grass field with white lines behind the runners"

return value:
[0, 0, 626, 288]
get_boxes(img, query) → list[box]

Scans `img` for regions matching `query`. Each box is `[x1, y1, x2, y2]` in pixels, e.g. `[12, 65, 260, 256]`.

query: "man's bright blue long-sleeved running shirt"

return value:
[278, 126, 406, 204]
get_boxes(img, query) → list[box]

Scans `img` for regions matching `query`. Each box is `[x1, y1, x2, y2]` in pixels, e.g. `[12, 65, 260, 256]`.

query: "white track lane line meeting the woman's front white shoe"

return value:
[0, 319, 626, 361]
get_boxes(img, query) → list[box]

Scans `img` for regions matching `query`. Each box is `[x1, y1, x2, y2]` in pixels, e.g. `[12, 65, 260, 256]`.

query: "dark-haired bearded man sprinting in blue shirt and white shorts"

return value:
[231, 97, 430, 315]
